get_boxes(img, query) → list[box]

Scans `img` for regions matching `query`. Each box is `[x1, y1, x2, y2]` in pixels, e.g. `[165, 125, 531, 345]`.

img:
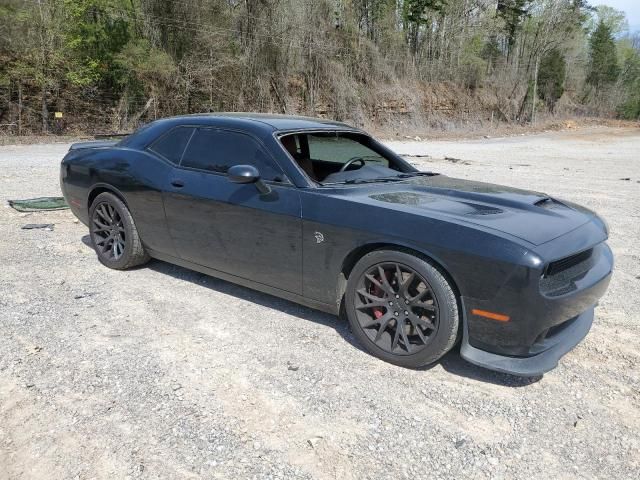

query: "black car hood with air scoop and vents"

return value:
[360, 175, 595, 245]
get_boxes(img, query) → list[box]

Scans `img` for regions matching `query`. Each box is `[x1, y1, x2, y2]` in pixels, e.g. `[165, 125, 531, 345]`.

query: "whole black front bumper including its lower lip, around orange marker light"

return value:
[461, 239, 613, 376]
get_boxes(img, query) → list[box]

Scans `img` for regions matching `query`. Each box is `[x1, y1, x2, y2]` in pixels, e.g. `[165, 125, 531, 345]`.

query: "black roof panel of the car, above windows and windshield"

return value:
[155, 112, 356, 131]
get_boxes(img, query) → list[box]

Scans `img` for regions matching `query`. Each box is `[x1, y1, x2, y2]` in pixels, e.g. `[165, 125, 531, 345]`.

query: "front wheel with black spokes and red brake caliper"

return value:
[344, 250, 460, 368]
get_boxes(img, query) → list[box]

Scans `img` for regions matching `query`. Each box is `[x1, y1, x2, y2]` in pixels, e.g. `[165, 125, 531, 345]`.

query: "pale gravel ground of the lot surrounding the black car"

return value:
[0, 128, 640, 479]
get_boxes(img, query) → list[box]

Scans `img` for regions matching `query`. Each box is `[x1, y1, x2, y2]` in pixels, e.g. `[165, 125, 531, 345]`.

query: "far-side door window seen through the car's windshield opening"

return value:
[307, 134, 389, 167]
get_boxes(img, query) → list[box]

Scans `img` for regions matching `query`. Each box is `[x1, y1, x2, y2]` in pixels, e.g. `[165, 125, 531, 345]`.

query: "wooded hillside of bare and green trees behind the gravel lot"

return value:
[0, 0, 640, 134]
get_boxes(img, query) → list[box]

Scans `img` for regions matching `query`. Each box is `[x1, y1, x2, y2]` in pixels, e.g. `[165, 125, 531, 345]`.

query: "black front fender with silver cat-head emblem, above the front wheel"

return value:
[303, 195, 531, 303]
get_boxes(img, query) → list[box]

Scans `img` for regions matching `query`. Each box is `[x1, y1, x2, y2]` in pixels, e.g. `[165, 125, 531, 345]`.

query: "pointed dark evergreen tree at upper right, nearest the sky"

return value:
[587, 20, 620, 91]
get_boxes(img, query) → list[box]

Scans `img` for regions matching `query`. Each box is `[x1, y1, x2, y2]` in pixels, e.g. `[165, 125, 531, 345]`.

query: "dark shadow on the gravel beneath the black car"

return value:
[82, 235, 542, 388]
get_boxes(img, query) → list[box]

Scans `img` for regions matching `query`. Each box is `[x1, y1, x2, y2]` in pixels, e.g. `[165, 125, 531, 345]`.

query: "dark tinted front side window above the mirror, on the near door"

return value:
[180, 128, 283, 181]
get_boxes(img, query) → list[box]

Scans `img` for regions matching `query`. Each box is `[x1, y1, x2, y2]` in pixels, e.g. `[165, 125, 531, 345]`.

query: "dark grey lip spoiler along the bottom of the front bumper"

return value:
[460, 308, 594, 377]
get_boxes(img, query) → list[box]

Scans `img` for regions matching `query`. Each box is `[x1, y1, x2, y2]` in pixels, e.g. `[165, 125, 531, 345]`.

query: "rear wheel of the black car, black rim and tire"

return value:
[89, 192, 149, 270]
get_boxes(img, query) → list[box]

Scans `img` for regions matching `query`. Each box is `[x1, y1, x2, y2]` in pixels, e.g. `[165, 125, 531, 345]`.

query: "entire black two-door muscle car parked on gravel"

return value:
[61, 114, 613, 376]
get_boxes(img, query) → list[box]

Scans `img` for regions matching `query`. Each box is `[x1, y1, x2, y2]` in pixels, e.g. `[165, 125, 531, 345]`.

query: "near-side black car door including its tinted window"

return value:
[164, 127, 302, 294]
